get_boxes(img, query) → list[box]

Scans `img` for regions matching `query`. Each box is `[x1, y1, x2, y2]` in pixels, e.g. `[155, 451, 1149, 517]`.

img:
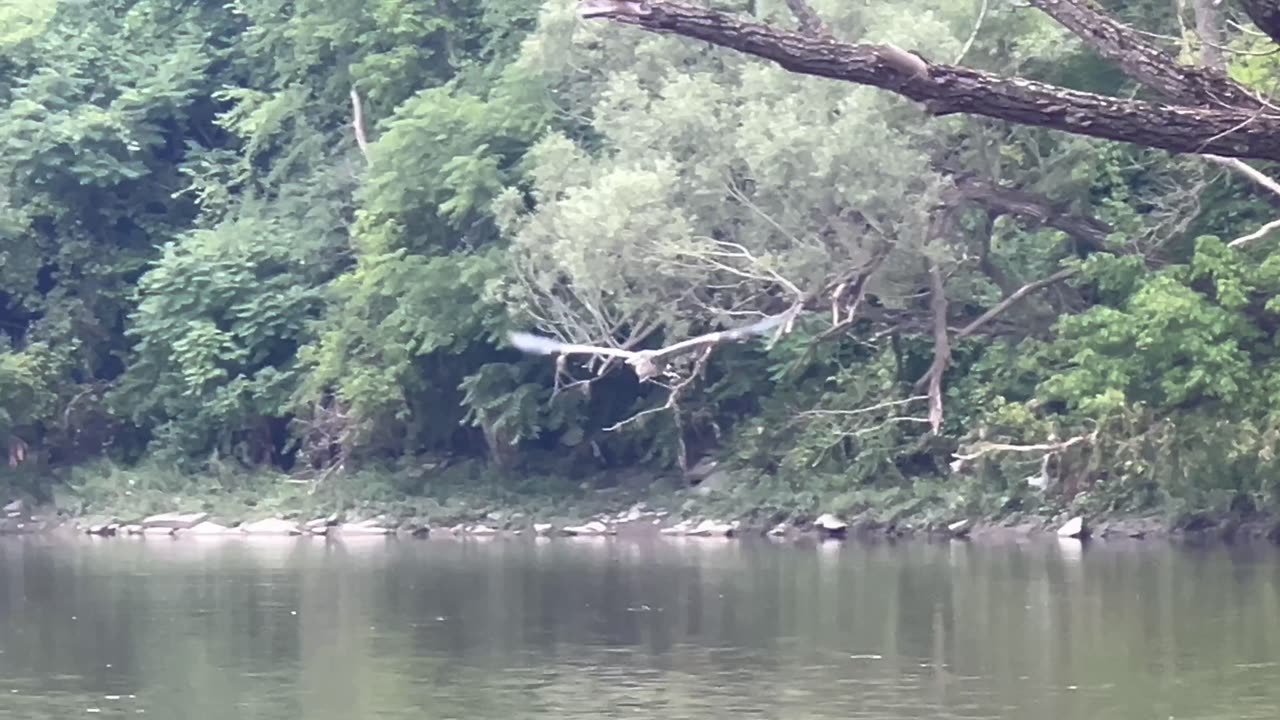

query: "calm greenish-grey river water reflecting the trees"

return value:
[0, 538, 1280, 720]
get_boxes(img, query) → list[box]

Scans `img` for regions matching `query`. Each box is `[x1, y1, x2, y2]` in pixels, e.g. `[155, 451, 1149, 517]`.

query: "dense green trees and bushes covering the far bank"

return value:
[0, 0, 1280, 523]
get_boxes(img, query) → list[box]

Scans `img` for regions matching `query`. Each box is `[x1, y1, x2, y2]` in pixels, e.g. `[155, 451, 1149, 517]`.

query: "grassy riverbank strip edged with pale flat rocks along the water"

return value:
[0, 456, 1280, 542]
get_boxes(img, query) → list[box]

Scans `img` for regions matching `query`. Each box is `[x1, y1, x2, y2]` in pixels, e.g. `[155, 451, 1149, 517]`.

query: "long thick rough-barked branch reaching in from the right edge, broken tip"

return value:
[579, 0, 1280, 160]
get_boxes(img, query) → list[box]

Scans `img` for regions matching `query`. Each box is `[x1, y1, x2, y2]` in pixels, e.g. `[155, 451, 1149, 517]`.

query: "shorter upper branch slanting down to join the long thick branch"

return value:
[1030, 0, 1262, 109]
